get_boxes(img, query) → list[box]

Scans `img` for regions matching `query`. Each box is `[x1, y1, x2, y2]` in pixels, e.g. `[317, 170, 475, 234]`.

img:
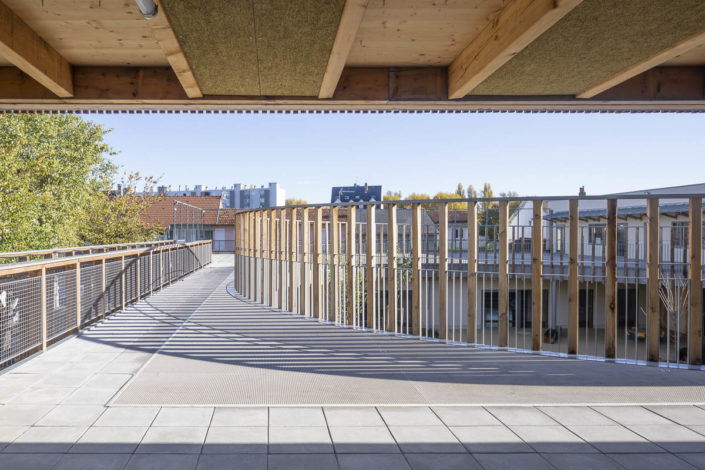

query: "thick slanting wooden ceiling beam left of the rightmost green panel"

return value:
[448, 0, 582, 99]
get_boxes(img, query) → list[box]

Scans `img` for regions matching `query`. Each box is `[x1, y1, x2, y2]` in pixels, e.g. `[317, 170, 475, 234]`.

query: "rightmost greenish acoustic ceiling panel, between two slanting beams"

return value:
[471, 0, 705, 95]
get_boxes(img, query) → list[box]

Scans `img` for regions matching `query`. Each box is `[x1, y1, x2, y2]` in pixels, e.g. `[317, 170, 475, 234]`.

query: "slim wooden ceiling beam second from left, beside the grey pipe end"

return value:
[146, 2, 203, 98]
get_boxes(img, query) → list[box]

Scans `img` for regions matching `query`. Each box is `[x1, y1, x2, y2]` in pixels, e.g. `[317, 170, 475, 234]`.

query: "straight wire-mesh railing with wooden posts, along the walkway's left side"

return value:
[0, 241, 211, 369]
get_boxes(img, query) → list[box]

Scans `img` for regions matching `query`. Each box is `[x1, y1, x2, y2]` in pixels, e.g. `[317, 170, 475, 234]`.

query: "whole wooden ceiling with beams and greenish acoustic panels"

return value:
[0, 0, 705, 112]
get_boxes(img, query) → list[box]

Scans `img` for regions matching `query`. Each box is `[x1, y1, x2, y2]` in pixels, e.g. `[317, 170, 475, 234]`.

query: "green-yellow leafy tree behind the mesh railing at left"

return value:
[0, 114, 161, 251]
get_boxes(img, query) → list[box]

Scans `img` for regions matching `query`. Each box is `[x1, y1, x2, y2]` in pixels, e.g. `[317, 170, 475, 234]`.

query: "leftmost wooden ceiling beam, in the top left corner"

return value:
[0, 1, 73, 98]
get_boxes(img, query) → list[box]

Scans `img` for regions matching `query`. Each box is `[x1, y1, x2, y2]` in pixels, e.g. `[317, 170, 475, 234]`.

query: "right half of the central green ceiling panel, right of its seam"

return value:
[255, 0, 345, 96]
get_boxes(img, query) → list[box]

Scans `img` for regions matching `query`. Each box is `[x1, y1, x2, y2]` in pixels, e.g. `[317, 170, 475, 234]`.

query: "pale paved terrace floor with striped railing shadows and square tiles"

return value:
[0, 255, 705, 470]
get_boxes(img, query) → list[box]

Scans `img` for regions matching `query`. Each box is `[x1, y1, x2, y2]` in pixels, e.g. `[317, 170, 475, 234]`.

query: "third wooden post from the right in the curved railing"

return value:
[605, 199, 617, 359]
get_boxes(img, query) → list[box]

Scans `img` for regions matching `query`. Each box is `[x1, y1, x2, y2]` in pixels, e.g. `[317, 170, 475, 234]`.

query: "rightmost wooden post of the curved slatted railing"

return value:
[688, 197, 703, 365]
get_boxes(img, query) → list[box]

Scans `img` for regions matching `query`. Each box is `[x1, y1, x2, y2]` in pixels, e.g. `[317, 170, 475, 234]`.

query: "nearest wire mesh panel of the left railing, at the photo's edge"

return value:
[0, 277, 42, 365]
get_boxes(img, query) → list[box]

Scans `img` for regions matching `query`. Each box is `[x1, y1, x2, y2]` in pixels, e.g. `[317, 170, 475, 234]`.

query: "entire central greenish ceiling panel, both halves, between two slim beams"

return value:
[162, 0, 345, 96]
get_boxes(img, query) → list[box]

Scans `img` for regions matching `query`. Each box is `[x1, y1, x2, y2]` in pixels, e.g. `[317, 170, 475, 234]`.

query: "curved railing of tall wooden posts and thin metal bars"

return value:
[235, 194, 704, 367]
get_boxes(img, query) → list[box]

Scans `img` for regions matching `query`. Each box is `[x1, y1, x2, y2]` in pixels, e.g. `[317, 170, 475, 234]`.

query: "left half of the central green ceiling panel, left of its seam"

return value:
[161, 0, 260, 95]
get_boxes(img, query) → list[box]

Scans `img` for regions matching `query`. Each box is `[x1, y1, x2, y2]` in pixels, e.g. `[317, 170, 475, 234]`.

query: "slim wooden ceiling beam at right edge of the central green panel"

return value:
[318, 0, 369, 99]
